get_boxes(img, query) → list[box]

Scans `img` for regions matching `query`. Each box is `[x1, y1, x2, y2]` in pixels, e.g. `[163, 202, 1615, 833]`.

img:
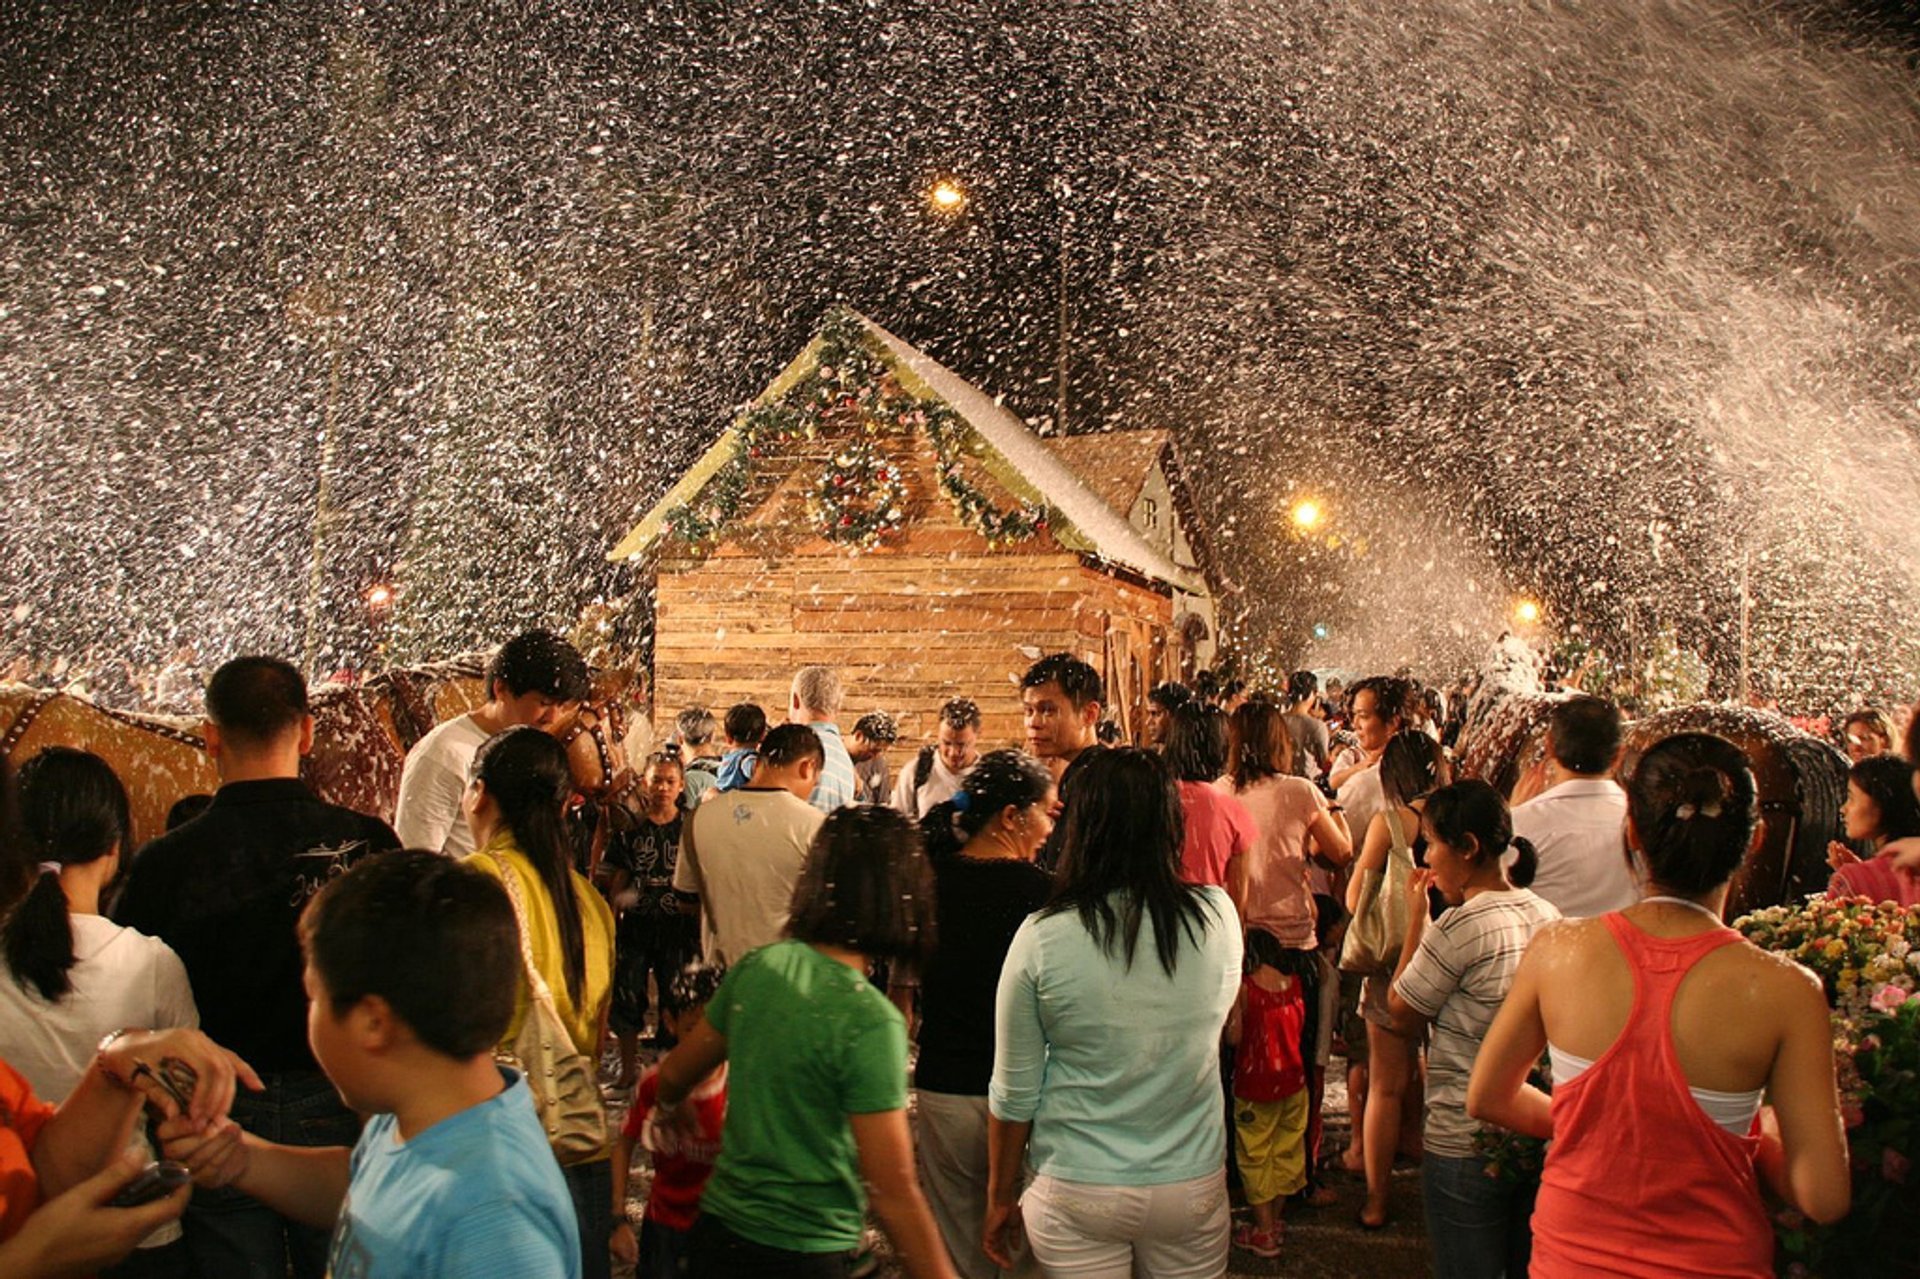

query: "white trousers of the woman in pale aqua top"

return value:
[1020, 1168, 1227, 1279]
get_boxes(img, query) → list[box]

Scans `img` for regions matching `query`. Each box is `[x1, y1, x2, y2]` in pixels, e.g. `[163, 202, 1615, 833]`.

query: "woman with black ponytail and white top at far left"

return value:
[0, 747, 200, 1275]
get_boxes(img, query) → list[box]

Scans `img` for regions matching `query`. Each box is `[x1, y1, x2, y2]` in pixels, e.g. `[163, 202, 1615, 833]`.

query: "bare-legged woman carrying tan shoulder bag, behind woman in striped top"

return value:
[1340, 728, 1450, 1231]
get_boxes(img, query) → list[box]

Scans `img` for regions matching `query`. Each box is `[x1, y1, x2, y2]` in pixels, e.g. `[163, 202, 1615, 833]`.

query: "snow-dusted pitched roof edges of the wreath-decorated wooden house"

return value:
[609, 315, 1208, 595]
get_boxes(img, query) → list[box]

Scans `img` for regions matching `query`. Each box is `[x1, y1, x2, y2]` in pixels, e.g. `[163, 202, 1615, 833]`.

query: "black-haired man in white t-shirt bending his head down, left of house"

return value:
[394, 630, 591, 857]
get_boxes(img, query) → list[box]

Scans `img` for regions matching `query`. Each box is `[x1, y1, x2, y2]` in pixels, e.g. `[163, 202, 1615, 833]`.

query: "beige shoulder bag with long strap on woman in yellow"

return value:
[493, 858, 612, 1168]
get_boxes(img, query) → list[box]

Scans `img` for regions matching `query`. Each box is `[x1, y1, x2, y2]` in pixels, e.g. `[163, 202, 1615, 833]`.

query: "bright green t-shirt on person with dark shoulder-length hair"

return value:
[701, 941, 906, 1252]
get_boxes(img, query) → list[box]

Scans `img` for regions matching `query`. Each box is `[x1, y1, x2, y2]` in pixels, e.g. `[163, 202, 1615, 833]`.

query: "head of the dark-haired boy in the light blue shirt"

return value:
[300, 851, 520, 1112]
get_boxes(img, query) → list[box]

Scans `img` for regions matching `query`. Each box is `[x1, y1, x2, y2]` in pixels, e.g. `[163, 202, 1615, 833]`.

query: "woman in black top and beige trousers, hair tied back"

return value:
[914, 751, 1054, 1279]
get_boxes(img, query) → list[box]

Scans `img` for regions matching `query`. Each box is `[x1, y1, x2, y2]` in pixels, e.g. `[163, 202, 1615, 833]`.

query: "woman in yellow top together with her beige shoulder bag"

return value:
[465, 728, 612, 1279]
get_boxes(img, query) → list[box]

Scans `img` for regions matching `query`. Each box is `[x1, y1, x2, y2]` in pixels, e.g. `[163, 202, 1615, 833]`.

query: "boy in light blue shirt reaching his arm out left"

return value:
[159, 853, 580, 1279]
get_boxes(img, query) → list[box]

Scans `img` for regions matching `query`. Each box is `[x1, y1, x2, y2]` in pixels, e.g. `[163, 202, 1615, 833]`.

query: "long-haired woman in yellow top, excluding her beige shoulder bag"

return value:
[465, 726, 612, 1279]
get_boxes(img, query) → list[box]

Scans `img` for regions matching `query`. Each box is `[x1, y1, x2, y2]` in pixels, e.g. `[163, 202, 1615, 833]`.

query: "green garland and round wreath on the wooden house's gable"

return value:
[662, 309, 1046, 545]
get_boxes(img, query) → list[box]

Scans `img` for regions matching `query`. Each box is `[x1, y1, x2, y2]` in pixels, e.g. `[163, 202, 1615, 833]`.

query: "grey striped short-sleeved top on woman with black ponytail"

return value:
[1394, 889, 1561, 1158]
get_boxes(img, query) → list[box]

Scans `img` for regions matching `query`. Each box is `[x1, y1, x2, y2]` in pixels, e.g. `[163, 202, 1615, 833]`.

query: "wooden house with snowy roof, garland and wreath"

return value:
[612, 311, 1215, 747]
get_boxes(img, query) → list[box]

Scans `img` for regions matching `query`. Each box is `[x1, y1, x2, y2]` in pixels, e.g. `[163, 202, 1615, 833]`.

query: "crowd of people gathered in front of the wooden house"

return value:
[0, 632, 1920, 1279]
